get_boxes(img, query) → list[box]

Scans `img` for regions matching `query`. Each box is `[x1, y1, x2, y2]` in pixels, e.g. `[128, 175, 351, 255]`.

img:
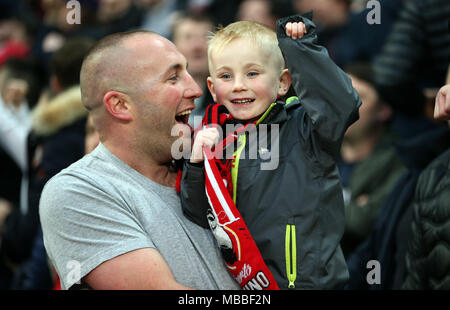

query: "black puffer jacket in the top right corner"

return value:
[374, 0, 450, 115]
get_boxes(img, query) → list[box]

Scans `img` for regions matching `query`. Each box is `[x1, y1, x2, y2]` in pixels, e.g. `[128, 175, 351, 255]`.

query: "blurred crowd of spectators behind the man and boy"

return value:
[0, 0, 450, 289]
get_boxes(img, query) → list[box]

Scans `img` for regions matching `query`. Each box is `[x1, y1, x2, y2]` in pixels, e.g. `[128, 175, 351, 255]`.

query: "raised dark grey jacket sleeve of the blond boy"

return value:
[277, 14, 361, 158]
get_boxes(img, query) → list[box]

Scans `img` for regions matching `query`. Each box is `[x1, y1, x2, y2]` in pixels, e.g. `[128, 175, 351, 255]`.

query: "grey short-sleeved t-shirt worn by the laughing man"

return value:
[39, 144, 239, 289]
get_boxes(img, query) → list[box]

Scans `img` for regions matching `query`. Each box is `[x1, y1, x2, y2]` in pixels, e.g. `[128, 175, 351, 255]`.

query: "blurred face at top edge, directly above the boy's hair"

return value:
[237, 0, 277, 29]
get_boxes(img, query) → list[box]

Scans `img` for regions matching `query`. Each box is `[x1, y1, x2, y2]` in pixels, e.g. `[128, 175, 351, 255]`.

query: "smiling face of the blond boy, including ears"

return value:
[208, 38, 290, 120]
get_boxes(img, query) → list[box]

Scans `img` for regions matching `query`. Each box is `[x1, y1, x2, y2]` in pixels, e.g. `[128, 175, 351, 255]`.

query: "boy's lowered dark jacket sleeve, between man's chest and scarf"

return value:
[180, 161, 209, 228]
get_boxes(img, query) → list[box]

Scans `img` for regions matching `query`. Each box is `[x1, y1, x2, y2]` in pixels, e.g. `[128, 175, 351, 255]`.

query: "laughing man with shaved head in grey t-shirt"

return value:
[40, 31, 238, 289]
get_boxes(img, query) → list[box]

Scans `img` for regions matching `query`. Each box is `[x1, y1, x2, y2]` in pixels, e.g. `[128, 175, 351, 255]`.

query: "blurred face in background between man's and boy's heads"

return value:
[173, 19, 213, 78]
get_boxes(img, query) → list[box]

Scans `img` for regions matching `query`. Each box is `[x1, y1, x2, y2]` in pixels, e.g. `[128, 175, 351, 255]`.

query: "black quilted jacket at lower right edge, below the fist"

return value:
[403, 149, 450, 290]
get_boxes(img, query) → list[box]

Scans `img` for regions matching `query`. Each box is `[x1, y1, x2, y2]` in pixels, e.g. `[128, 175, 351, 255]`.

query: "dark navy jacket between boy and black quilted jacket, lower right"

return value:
[346, 127, 450, 289]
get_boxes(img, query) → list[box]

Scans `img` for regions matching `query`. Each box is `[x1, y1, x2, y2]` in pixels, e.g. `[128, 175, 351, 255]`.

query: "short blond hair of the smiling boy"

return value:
[208, 21, 285, 72]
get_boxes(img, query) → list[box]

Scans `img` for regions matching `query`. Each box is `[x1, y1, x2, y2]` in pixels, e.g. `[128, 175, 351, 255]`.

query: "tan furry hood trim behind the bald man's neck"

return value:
[32, 86, 88, 136]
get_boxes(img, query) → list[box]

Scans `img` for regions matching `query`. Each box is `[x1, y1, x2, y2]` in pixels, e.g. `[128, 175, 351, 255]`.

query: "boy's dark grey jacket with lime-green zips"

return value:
[181, 16, 360, 289]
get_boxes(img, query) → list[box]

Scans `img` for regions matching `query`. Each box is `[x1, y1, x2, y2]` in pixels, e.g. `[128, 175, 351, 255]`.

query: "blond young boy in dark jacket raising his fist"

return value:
[181, 16, 360, 289]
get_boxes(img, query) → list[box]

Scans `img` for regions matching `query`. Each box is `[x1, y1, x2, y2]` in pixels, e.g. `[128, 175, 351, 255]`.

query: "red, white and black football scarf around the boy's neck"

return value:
[203, 104, 279, 290]
